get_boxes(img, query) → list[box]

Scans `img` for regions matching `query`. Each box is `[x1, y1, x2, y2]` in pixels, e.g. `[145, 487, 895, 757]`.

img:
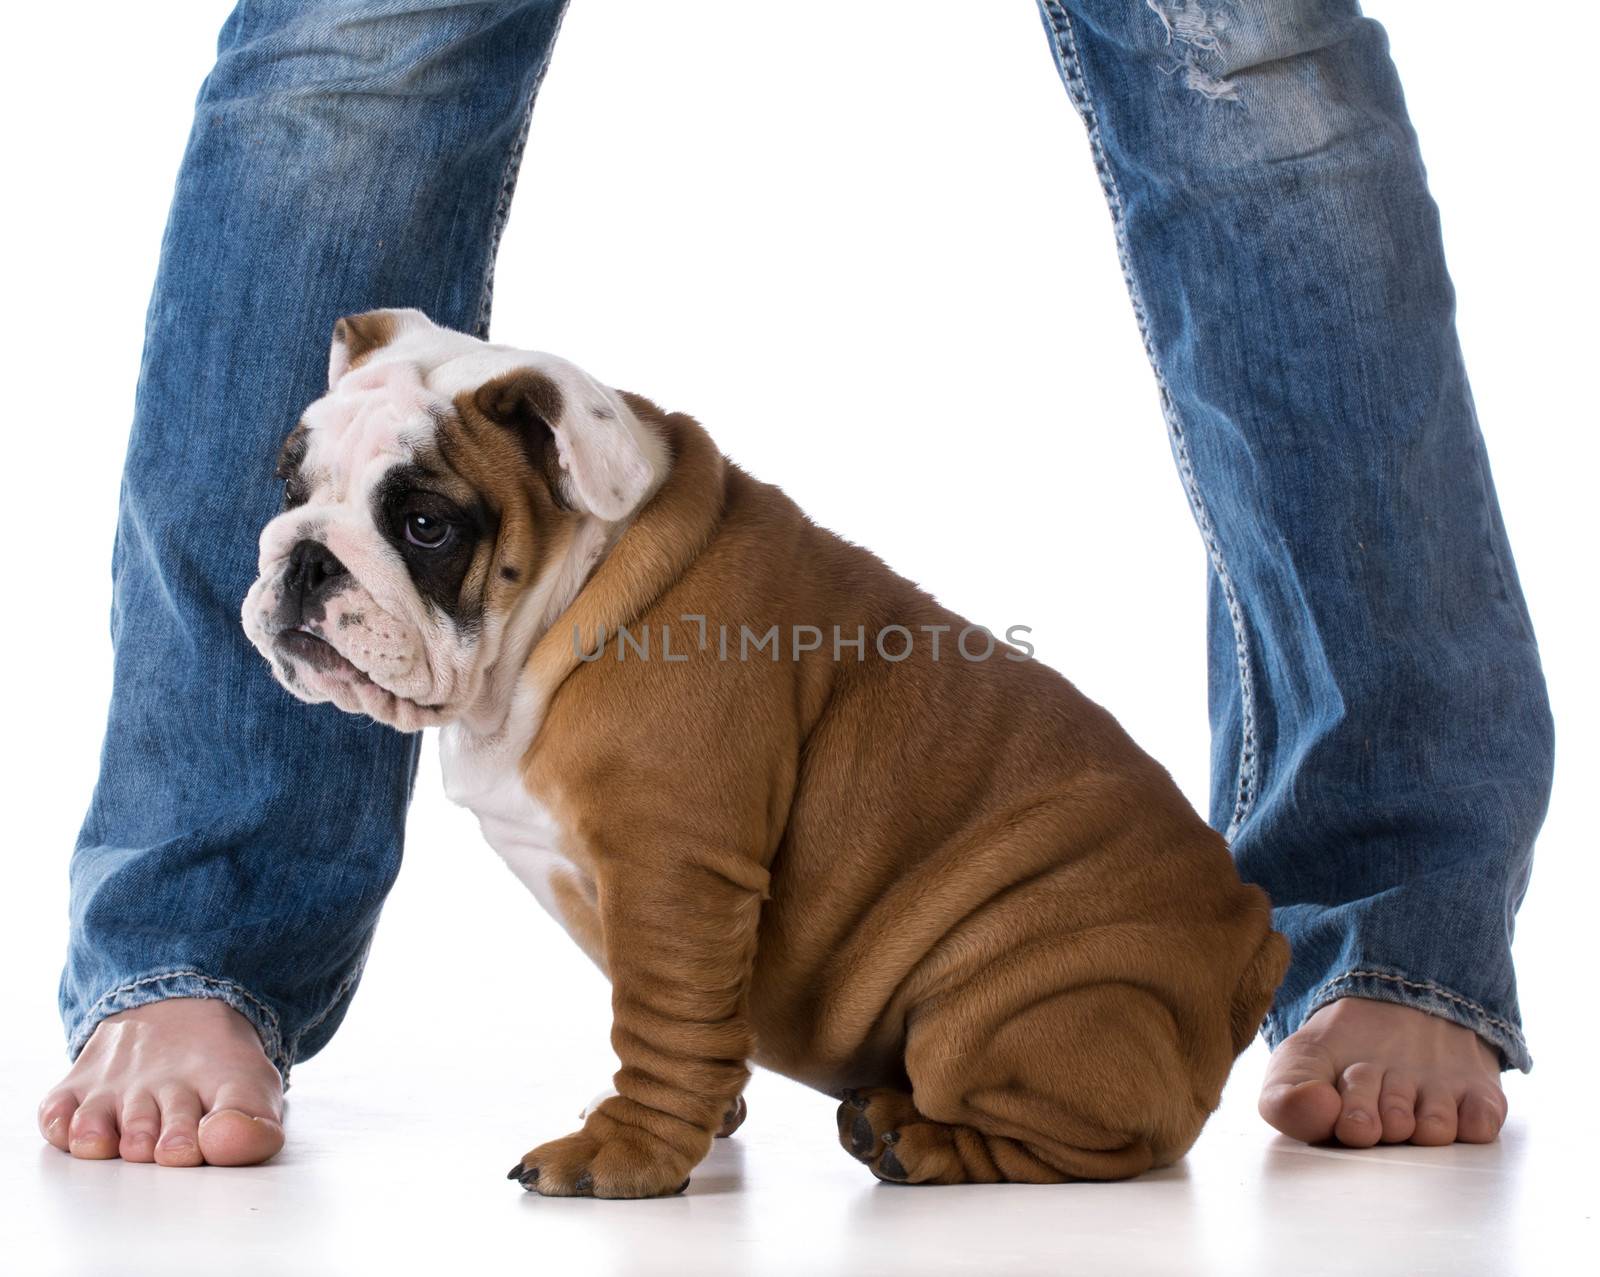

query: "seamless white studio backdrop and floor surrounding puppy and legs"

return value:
[0, 0, 1600, 1277]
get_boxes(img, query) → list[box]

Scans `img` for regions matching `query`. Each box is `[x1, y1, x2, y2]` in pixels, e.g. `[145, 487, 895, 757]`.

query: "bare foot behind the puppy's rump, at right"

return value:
[1259, 997, 1506, 1149]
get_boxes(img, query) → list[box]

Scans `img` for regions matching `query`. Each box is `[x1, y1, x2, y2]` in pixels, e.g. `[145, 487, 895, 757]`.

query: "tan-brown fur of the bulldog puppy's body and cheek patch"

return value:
[505, 397, 1288, 1197]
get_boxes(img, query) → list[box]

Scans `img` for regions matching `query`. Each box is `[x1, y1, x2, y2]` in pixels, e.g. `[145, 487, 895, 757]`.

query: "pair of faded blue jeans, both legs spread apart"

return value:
[61, 0, 1552, 1075]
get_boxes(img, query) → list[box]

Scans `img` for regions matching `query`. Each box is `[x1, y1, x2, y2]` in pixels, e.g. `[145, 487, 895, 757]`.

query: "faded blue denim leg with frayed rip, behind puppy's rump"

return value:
[1040, 0, 1552, 1069]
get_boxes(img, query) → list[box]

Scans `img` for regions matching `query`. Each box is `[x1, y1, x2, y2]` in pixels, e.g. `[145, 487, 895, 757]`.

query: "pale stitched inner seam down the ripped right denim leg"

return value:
[1042, 0, 1259, 840]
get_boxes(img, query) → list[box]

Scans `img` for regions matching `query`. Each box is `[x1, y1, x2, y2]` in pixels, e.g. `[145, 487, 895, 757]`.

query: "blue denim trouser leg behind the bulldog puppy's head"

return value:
[61, 0, 565, 1077]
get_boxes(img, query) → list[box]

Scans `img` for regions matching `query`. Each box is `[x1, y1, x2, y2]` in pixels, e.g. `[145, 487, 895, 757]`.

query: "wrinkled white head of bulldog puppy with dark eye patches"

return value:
[243, 310, 666, 731]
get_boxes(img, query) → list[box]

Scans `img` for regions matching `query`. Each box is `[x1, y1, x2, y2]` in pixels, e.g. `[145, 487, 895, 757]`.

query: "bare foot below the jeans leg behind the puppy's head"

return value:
[38, 997, 283, 1167]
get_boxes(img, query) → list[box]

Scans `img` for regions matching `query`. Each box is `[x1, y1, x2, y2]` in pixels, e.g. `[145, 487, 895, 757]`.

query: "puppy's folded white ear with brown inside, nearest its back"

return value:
[474, 368, 654, 522]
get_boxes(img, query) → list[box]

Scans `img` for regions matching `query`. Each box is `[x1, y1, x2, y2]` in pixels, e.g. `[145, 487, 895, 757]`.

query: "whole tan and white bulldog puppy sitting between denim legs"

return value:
[243, 310, 1288, 1197]
